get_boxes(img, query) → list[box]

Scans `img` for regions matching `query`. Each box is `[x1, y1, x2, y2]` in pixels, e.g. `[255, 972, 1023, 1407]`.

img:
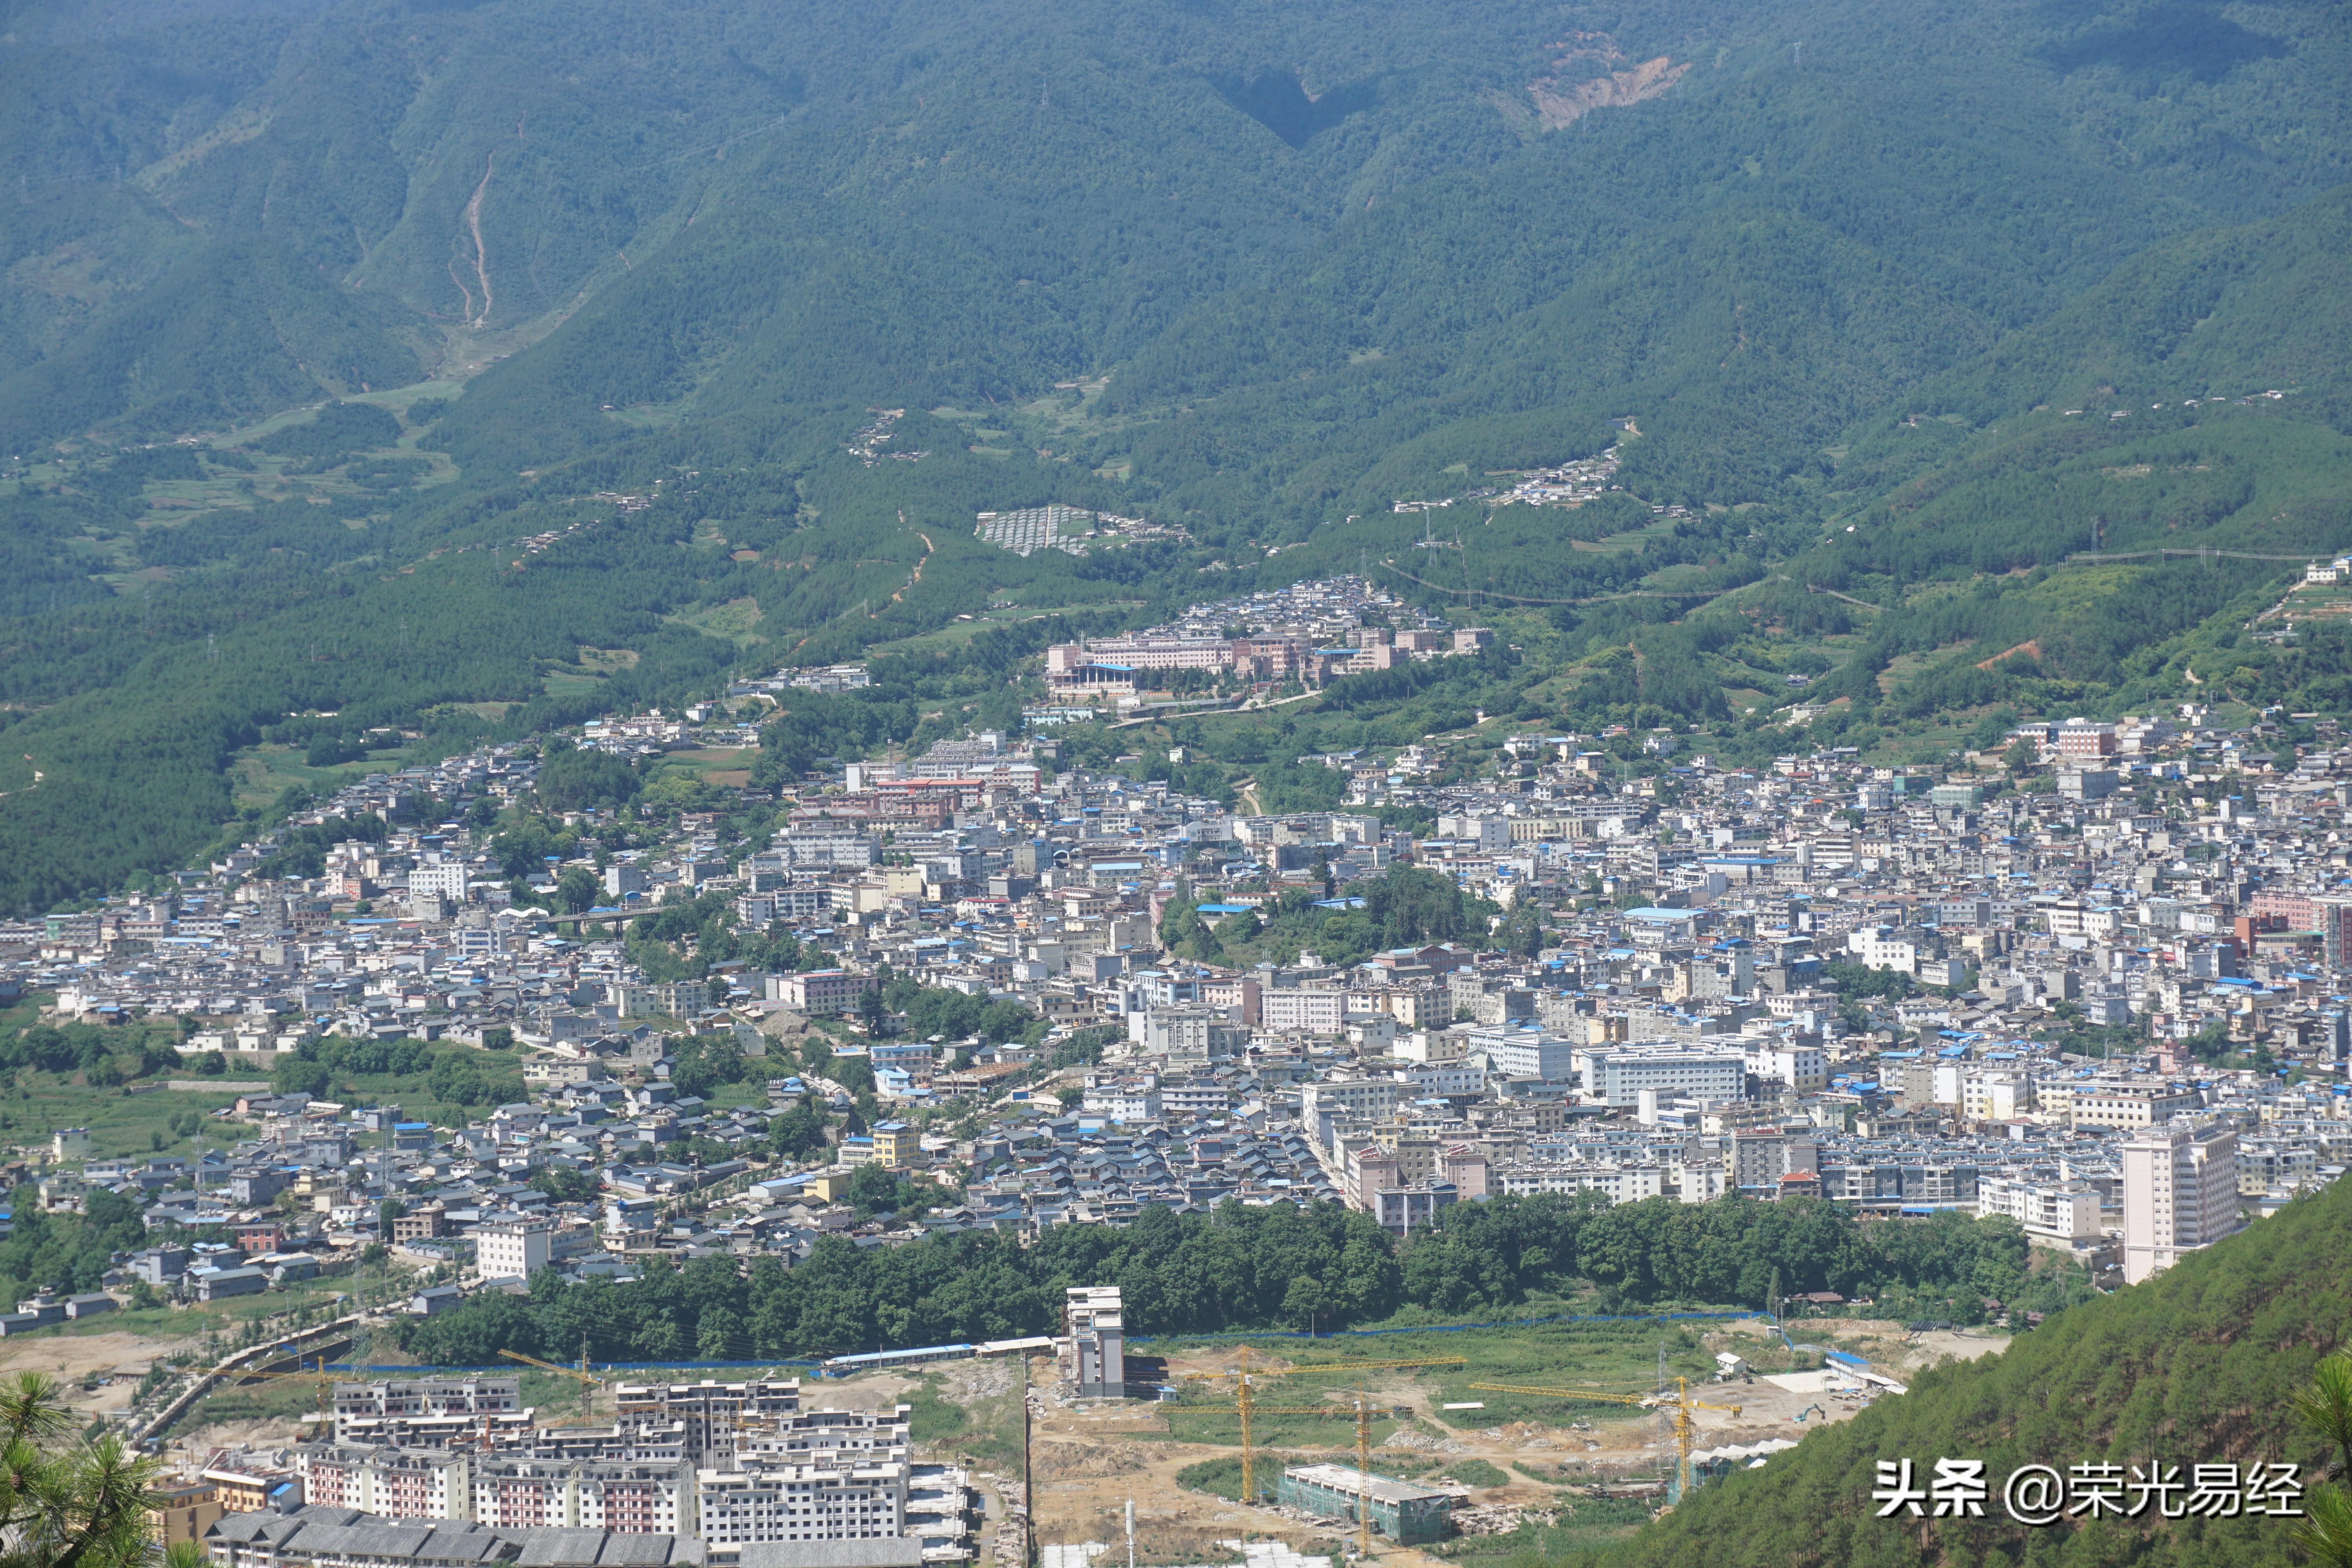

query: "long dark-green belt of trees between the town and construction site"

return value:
[402, 1194, 2086, 1366]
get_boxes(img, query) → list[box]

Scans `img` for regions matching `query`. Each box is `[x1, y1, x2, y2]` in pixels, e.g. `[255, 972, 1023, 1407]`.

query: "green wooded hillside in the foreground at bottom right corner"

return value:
[1609, 1185, 2352, 1568]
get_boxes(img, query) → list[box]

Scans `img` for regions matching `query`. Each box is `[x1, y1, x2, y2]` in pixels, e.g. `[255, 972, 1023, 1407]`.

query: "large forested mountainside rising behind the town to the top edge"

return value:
[0, 0, 2352, 910]
